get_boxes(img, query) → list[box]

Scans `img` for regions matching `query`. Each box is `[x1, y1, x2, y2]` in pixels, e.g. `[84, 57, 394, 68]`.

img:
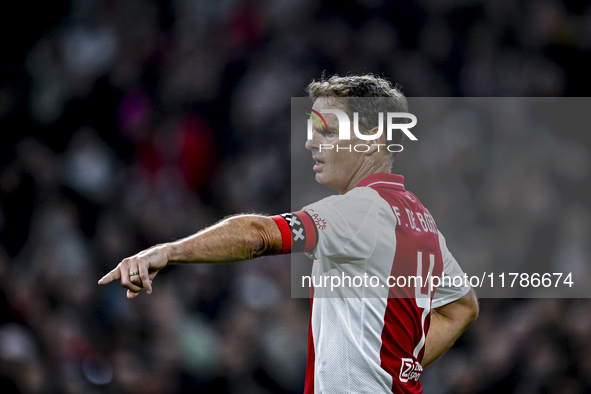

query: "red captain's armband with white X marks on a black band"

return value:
[271, 211, 318, 254]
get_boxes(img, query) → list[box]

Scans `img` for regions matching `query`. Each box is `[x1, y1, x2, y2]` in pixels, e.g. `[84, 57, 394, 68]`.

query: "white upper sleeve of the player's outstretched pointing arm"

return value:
[304, 187, 379, 263]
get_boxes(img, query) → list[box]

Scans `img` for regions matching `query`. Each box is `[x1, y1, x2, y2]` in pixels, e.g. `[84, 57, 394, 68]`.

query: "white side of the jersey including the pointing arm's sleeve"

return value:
[305, 188, 396, 394]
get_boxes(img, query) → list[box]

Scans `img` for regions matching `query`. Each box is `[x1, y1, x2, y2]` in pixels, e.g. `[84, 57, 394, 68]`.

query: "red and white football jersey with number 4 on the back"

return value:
[274, 173, 470, 394]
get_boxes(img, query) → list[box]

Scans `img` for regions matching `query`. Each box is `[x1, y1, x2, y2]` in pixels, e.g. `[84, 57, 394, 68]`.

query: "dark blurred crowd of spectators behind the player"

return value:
[0, 0, 591, 394]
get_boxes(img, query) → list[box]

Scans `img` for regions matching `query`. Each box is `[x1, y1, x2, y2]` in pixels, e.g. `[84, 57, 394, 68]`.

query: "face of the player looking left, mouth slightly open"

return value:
[306, 97, 365, 194]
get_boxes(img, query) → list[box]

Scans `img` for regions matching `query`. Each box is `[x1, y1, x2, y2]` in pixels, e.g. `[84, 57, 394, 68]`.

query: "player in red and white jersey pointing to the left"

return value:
[99, 75, 478, 394]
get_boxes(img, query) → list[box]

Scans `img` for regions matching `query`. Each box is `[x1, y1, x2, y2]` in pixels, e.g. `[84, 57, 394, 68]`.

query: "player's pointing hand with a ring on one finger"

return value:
[98, 244, 170, 299]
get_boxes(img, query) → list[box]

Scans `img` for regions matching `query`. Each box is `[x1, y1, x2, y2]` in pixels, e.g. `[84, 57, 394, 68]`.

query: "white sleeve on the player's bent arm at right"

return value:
[431, 231, 470, 308]
